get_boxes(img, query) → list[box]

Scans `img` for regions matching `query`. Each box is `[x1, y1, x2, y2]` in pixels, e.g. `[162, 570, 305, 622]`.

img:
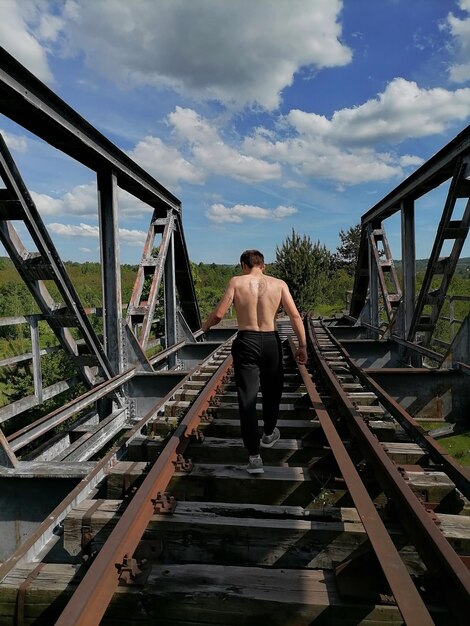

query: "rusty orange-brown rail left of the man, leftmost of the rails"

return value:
[56, 356, 232, 626]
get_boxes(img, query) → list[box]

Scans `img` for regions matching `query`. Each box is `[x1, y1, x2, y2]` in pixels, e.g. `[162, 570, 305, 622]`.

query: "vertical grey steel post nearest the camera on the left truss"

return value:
[97, 170, 123, 373]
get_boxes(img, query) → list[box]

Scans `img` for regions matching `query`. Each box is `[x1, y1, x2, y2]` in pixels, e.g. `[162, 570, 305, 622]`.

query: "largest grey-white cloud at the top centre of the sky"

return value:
[42, 0, 352, 109]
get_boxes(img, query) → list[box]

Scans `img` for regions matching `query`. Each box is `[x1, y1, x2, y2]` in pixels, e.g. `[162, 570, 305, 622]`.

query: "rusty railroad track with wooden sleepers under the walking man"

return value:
[0, 320, 470, 626]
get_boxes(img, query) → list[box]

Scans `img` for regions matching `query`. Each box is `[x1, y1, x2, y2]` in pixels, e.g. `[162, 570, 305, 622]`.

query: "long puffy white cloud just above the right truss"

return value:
[244, 78, 470, 185]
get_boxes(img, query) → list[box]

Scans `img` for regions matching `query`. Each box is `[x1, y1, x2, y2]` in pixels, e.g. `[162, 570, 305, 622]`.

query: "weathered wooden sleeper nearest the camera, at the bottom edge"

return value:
[0, 564, 450, 626]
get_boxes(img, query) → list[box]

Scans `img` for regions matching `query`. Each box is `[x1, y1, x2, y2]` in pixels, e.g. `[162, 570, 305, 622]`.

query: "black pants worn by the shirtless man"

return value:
[232, 330, 284, 455]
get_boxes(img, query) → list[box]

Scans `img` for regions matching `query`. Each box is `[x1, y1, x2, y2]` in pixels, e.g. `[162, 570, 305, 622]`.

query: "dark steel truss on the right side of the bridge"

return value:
[349, 126, 470, 364]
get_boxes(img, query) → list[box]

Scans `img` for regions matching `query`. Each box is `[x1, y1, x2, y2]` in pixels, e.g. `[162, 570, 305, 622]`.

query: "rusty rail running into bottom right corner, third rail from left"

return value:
[308, 320, 470, 624]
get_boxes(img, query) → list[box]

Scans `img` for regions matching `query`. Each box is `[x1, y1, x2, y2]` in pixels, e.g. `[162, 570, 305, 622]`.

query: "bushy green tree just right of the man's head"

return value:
[273, 229, 332, 312]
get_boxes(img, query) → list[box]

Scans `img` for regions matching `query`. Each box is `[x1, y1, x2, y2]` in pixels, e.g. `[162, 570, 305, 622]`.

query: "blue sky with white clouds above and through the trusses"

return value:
[0, 0, 470, 263]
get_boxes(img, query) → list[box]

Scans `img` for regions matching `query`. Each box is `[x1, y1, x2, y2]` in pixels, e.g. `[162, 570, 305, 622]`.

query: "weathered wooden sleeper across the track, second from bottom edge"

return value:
[64, 500, 470, 575]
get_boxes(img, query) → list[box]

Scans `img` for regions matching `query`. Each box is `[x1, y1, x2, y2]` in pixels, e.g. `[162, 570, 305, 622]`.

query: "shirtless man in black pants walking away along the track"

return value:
[202, 250, 307, 474]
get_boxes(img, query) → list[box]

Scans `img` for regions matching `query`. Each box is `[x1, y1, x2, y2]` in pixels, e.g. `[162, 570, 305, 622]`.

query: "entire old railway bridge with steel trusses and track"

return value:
[0, 50, 470, 626]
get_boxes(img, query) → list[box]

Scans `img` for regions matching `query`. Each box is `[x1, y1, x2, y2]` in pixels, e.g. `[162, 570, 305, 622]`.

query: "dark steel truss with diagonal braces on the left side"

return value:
[0, 48, 201, 386]
